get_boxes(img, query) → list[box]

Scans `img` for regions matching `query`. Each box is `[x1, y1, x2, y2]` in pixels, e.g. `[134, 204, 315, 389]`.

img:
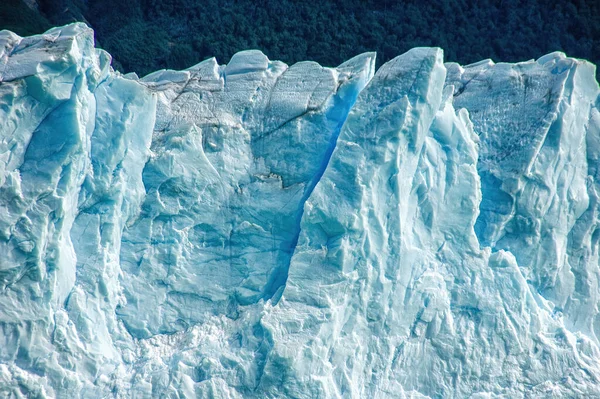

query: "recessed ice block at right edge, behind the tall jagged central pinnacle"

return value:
[448, 53, 600, 342]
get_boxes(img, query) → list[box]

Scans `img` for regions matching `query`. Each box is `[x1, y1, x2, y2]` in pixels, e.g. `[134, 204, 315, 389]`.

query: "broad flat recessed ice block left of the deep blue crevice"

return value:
[117, 51, 374, 337]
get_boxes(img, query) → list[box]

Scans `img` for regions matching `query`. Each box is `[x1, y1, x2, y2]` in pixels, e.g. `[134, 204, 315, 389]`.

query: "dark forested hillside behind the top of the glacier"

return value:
[0, 0, 600, 75]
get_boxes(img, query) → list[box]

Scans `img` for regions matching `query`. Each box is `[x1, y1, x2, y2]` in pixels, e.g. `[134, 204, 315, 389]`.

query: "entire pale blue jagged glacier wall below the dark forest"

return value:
[0, 24, 600, 398]
